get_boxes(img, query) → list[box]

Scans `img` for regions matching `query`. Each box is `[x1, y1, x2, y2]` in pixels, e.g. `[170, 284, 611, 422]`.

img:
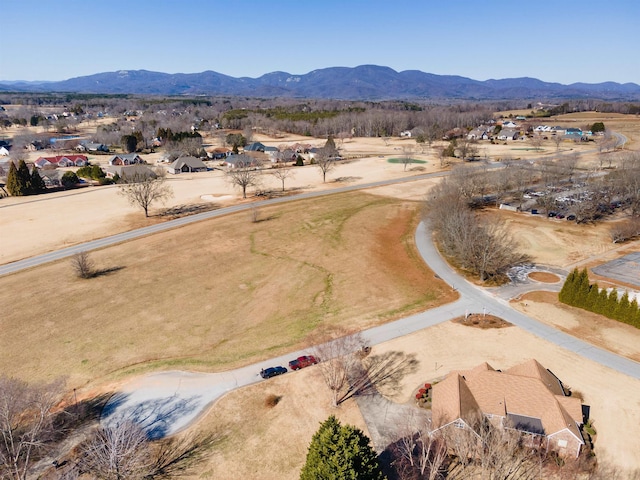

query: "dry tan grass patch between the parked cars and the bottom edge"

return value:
[188, 367, 367, 480]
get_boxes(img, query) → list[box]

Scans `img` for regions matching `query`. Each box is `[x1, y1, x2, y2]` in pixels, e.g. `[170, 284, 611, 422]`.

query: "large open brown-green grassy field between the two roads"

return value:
[0, 189, 451, 387]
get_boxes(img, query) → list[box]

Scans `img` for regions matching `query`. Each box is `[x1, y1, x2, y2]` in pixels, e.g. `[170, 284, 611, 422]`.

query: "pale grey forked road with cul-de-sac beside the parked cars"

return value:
[103, 223, 640, 438]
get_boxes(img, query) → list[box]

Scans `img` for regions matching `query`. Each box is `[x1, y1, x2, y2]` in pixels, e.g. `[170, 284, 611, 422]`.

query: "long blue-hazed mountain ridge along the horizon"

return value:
[0, 65, 640, 100]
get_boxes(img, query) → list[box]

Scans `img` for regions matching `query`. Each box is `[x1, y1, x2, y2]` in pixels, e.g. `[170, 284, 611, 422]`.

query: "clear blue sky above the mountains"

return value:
[0, 0, 640, 84]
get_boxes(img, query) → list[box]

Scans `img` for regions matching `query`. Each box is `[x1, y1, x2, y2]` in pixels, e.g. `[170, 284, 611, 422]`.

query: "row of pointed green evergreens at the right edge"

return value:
[558, 268, 640, 328]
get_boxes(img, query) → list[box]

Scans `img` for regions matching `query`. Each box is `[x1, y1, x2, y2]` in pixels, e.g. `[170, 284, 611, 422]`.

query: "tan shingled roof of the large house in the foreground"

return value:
[432, 360, 583, 442]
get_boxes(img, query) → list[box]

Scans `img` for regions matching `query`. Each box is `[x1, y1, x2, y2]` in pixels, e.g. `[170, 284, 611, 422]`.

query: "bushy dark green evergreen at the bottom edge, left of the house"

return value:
[300, 415, 385, 480]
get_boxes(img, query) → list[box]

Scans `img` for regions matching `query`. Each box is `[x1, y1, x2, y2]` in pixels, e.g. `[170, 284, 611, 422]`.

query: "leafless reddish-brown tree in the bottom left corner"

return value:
[0, 376, 63, 480]
